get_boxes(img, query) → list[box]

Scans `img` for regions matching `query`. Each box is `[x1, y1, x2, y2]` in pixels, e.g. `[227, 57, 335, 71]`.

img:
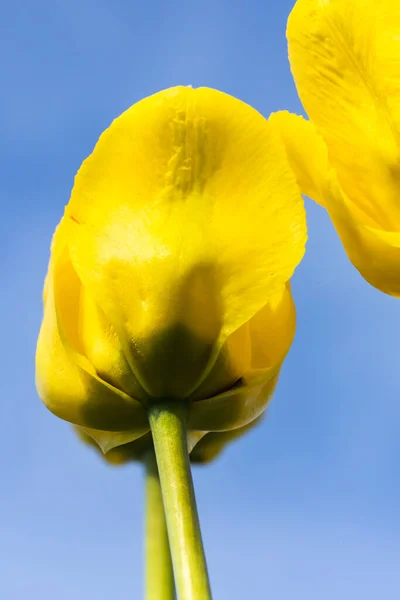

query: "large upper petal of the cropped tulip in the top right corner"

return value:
[287, 0, 400, 231]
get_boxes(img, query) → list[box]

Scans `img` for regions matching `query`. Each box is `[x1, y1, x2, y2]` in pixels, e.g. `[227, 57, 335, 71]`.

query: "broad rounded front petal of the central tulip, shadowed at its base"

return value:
[66, 87, 306, 397]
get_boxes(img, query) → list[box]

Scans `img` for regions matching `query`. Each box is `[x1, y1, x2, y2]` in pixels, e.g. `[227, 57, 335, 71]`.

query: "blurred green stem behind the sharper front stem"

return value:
[143, 450, 175, 600]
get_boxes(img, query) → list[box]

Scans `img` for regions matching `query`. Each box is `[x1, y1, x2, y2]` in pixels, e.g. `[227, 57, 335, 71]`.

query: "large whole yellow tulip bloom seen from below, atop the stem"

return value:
[36, 87, 306, 450]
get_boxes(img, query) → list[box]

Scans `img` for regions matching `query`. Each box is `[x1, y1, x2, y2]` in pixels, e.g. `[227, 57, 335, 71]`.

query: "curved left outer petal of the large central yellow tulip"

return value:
[36, 220, 149, 435]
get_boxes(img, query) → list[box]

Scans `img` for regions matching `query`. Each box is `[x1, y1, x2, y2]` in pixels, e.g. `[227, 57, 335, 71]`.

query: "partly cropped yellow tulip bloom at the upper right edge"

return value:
[274, 0, 400, 296]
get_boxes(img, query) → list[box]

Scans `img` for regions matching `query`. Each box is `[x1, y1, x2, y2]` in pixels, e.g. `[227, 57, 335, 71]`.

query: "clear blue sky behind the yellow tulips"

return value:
[0, 0, 400, 600]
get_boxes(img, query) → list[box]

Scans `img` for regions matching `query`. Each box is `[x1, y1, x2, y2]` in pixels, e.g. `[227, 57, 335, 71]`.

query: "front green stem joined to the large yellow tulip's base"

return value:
[149, 401, 211, 600]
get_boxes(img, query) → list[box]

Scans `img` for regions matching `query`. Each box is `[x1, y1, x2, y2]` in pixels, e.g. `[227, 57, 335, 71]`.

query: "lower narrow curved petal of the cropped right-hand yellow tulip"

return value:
[270, 112, 400, 296]
